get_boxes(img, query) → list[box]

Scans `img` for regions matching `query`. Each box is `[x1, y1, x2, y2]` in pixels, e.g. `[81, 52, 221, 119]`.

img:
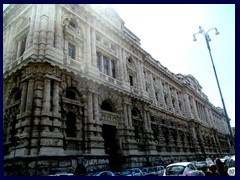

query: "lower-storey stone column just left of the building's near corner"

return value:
[26, 79, 34, 115]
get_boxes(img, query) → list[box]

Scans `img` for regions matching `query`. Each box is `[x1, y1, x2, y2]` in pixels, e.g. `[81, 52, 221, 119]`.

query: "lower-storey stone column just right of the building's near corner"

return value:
[42, 77, 51, 115]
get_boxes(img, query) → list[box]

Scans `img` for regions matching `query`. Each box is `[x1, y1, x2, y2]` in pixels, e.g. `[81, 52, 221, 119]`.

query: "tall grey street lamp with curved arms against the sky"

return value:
[193, 26, 234, 148]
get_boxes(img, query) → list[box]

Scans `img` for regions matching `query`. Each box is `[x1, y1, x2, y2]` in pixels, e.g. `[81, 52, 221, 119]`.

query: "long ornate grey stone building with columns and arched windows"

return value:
[3, 4, 234, 175]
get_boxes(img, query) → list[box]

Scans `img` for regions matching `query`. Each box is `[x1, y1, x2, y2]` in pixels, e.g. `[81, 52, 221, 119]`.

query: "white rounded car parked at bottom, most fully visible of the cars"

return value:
[164, 162, 197, 176]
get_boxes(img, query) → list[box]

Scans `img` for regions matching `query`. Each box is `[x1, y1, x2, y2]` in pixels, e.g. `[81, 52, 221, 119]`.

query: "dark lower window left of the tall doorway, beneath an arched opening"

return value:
[66, 112, 76, 137]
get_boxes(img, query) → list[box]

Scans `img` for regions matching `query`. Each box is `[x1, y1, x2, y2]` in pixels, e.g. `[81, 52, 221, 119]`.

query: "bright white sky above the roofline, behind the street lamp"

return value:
[3, 4, 235, 127]
